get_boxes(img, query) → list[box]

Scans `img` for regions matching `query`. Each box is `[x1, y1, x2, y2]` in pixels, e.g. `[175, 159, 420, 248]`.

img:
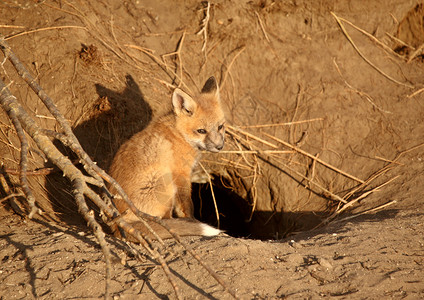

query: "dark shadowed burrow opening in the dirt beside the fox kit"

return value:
[192, 176, 328, 240]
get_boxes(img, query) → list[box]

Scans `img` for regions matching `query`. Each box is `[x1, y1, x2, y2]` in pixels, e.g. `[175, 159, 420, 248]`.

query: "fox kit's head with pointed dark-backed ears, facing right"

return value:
[172, 77, 225, 152]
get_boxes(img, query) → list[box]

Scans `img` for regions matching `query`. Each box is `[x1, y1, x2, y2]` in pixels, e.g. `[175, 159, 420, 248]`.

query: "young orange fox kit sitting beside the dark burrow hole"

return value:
[109, 77, 225, 238]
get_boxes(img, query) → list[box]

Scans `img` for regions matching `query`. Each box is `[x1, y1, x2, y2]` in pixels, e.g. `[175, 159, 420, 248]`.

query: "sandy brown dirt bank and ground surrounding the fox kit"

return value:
[0, 0, 424, 299]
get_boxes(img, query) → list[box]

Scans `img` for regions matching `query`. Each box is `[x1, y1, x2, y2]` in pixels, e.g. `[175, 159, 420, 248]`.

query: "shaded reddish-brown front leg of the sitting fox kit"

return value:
[174, 177, 194, 218]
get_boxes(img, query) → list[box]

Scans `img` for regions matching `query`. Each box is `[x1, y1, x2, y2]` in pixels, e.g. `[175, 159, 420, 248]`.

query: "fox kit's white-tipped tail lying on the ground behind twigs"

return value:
[113, 218, 222, 241]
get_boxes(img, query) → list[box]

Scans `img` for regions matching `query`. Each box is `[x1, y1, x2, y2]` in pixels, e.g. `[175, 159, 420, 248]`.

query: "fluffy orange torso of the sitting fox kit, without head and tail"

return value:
[110, 116, 200, 220]
